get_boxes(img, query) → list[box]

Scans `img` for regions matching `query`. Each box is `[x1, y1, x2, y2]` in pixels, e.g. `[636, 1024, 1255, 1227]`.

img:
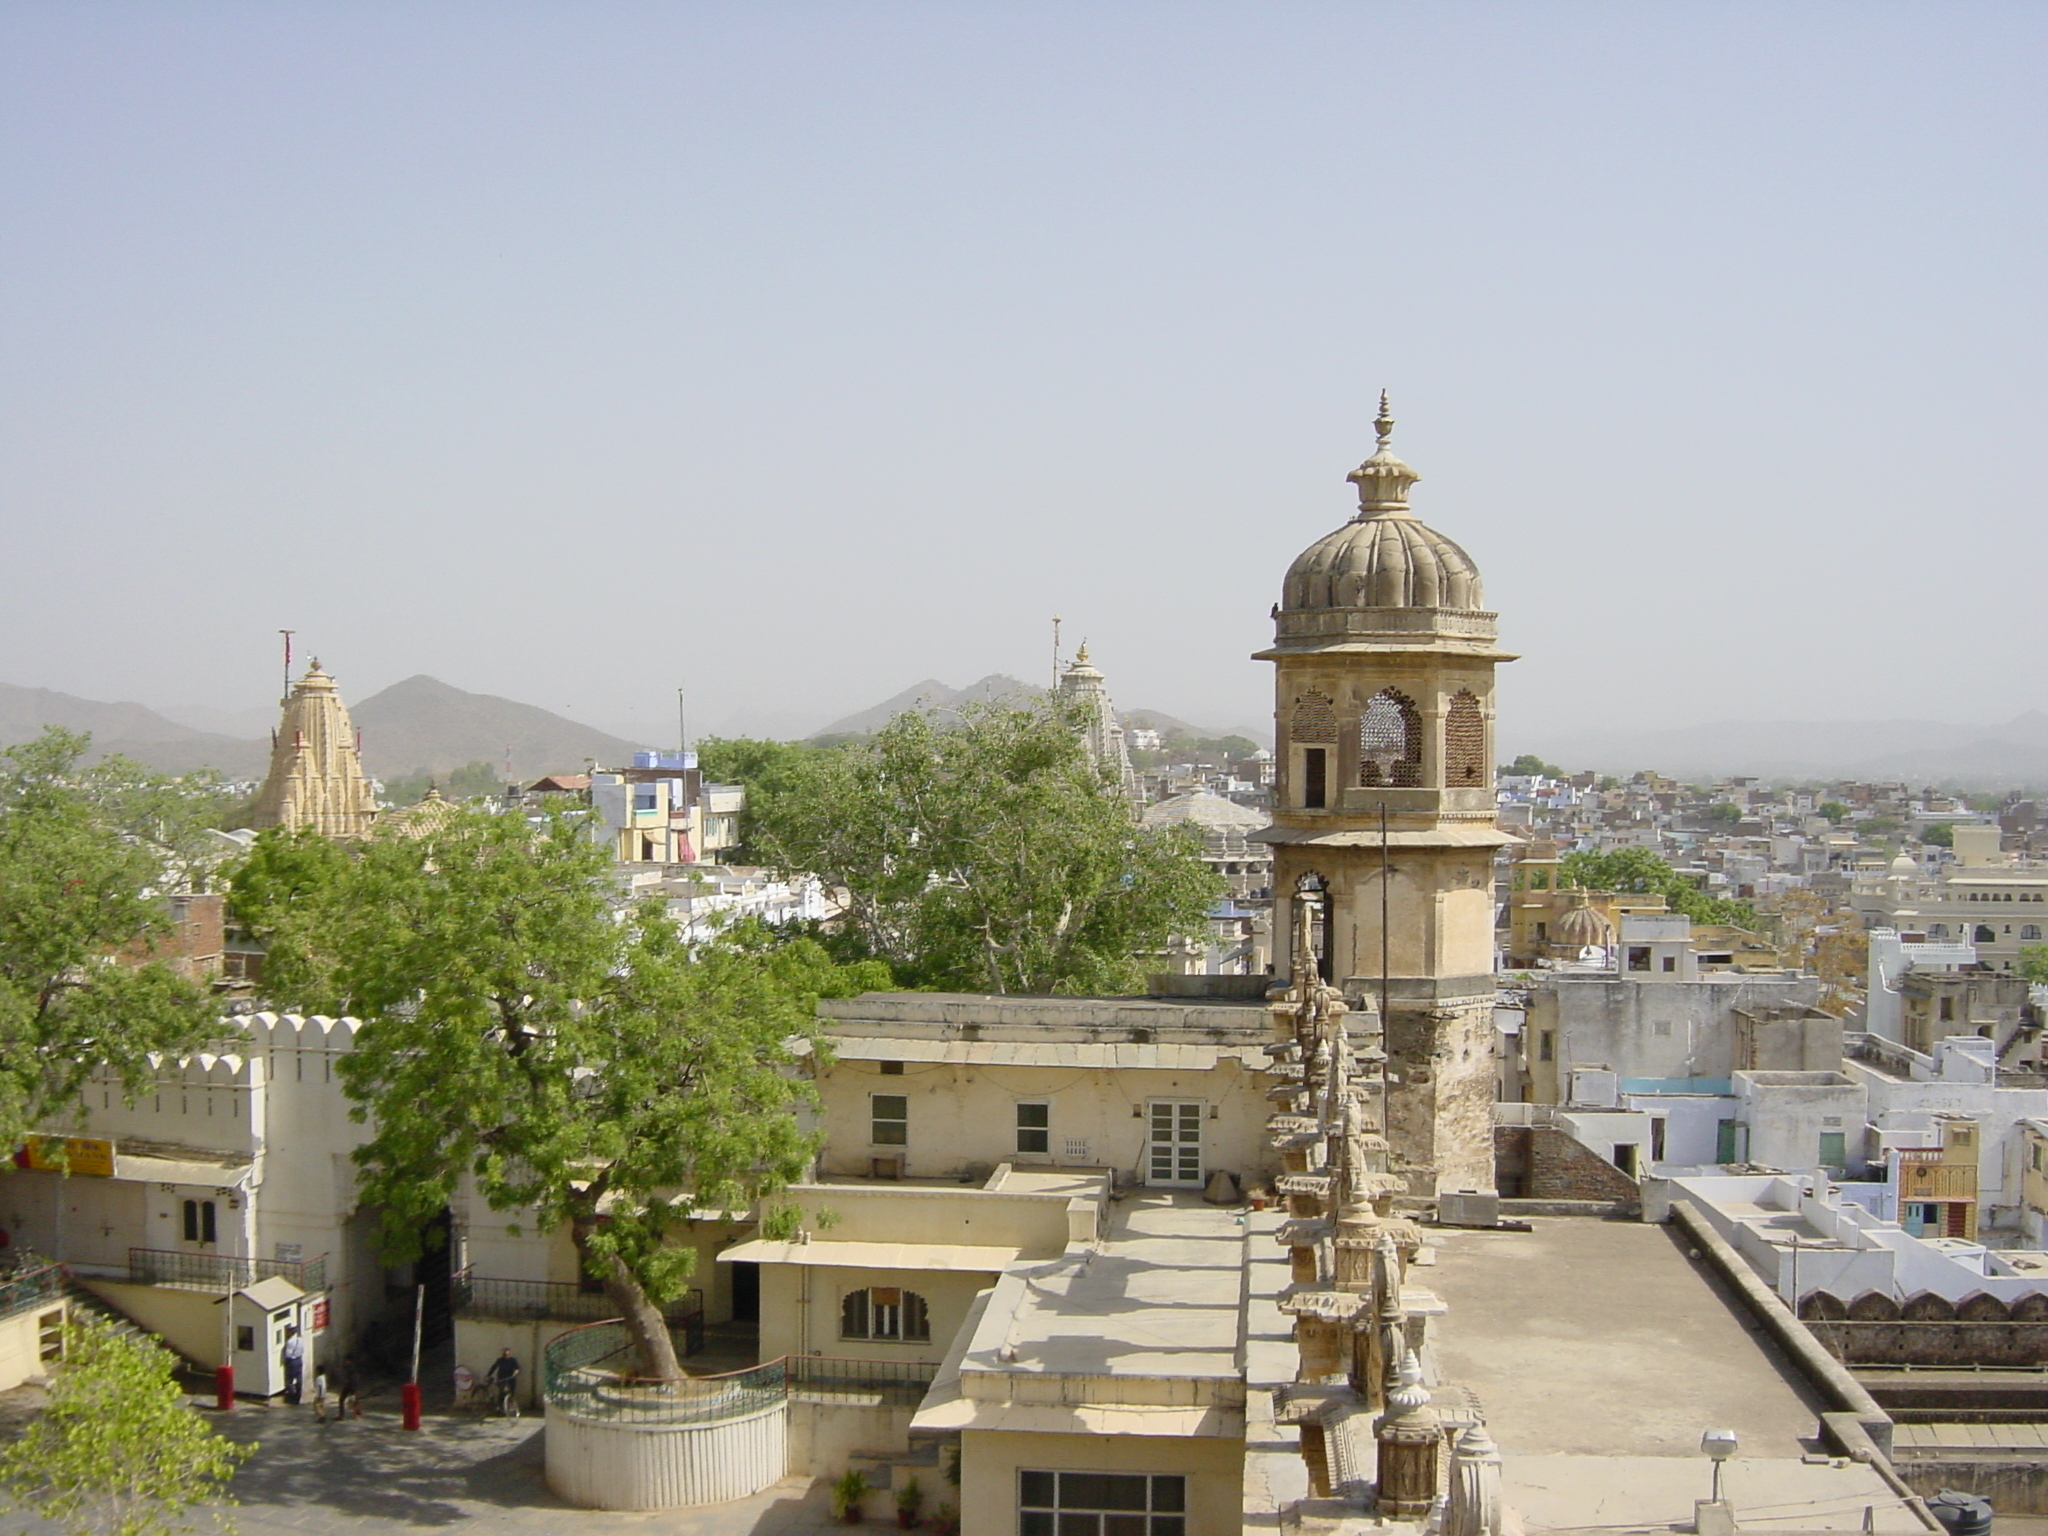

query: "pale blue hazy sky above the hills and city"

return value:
[0, 0, 2048, 748]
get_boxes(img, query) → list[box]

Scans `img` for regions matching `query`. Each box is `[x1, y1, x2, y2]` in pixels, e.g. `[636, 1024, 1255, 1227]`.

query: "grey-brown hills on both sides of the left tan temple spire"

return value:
[0, 676, 639, 780]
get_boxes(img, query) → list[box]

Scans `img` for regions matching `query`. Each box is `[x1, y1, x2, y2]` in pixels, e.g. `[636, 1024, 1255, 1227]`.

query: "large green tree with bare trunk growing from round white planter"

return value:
[268, 809, 887, 1380]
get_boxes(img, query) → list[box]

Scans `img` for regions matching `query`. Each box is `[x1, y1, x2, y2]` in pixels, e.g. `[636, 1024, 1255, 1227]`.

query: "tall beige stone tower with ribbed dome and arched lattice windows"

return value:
[1257, 395, 1516, 1194]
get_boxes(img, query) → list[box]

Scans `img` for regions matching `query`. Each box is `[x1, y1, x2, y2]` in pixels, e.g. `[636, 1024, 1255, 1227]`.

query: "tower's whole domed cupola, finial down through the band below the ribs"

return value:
[1276, 391, 1493, 645]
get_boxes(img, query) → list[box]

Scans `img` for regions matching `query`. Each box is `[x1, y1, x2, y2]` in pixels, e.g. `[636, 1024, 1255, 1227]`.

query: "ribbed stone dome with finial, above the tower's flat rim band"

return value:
[1280, 395, 1485, 610]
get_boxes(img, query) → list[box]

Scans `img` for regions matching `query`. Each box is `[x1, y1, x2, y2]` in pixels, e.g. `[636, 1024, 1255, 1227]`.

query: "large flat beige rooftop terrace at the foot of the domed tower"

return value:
[1423, 1219, 1921, 1532]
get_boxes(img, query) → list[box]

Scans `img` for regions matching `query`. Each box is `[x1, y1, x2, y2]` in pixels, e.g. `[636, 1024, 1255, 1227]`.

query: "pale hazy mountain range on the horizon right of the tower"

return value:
[1501, 709, 2048, 788]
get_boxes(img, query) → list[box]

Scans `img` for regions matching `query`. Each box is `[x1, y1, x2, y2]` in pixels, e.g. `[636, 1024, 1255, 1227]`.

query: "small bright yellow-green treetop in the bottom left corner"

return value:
[0, 1317, 254, 1536]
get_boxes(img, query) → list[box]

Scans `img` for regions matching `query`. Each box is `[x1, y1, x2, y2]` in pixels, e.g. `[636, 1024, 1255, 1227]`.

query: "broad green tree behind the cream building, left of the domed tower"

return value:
[758, 700, 1225, 993]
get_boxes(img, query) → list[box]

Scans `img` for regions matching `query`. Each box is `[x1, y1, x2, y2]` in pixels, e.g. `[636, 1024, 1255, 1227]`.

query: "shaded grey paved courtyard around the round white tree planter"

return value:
[0, 1393, 856, 1536]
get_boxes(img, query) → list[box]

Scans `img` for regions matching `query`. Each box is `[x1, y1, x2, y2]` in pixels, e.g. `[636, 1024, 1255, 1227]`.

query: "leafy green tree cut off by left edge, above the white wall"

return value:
[0, 729, 217, 1147]
